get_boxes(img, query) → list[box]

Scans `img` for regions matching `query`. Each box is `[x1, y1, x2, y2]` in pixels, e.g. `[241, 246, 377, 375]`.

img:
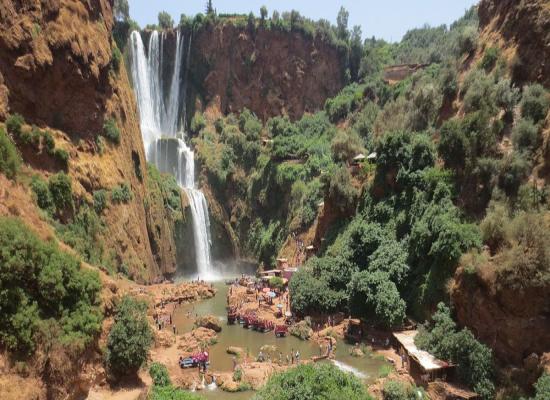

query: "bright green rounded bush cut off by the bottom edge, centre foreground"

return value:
[254, 364, 371, 400]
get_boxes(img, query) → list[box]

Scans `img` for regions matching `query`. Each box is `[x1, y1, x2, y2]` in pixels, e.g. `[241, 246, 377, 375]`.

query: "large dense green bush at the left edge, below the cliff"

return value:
[0, 218, 101, 355]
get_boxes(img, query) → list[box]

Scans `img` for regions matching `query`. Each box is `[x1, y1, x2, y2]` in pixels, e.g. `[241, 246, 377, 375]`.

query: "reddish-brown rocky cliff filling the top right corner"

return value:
[479, 0, 550, 87]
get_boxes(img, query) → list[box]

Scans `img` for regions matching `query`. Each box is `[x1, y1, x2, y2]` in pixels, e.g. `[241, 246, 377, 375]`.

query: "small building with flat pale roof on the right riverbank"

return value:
[393, 330, 455, 383]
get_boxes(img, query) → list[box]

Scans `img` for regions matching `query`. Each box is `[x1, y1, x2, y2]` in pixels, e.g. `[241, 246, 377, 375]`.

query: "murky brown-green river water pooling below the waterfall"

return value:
[174, 282, 387, 400]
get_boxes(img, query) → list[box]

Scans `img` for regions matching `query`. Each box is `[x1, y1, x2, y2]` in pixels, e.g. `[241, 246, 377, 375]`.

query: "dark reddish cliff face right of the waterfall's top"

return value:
[188, 23, 343, 120]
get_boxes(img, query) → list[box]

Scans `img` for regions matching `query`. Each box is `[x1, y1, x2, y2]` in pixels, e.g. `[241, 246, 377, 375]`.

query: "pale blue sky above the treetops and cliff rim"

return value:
[129, 0, 478, 42]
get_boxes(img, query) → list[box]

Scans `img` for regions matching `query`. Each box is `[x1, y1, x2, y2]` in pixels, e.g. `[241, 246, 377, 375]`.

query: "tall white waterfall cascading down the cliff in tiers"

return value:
[130, 31, 217, 280]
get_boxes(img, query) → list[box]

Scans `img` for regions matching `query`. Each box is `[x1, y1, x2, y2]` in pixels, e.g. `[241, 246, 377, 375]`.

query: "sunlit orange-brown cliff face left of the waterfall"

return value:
[0, 0, 187, 282]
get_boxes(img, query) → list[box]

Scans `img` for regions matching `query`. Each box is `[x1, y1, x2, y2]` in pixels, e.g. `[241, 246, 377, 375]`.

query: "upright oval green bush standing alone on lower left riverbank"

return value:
[105, 296, 153, 377]
